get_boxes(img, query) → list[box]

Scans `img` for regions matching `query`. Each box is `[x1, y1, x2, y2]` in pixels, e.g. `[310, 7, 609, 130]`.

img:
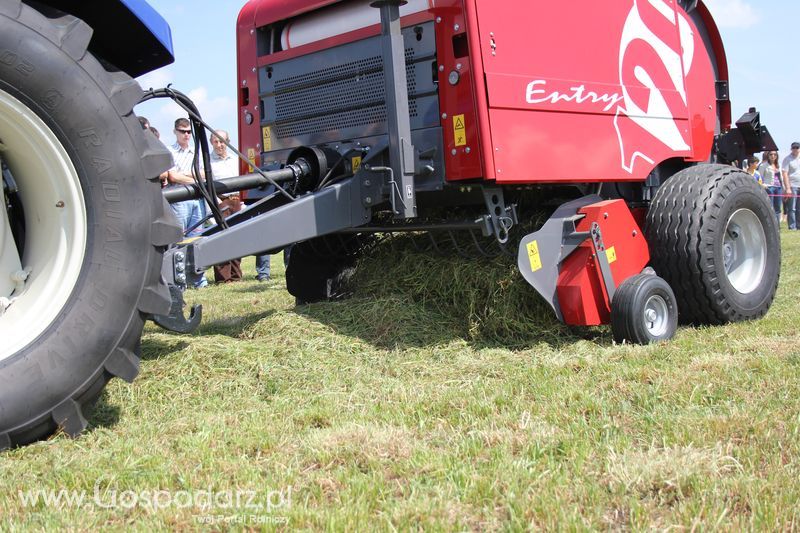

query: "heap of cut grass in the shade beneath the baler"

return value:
[324, 235, 575, 346]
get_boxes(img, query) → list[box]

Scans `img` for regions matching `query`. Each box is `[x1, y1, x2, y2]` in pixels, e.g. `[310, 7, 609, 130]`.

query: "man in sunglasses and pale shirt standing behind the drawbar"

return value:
[166, 118, 208, 289]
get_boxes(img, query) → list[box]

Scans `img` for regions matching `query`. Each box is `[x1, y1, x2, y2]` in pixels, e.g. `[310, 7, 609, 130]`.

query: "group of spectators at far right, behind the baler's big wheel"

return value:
[747, 142, 800, 229]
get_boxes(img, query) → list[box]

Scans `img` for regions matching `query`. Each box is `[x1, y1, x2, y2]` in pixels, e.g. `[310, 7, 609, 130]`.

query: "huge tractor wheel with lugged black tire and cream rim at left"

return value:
[0, 0, 180, 448]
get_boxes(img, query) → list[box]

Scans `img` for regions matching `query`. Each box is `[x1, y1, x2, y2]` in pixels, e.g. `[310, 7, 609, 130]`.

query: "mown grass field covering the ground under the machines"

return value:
[0, 232, 800, 531]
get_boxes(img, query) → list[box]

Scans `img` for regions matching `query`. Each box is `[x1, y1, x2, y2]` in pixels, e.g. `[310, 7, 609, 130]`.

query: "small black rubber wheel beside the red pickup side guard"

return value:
[611, 274, 678, 344]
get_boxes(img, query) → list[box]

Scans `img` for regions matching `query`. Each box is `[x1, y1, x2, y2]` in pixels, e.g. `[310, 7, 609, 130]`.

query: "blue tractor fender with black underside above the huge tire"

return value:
[35, 0, 175, 77]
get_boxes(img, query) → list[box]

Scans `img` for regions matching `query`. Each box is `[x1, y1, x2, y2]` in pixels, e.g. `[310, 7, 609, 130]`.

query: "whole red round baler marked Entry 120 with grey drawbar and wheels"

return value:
[161, 0, 780, 342]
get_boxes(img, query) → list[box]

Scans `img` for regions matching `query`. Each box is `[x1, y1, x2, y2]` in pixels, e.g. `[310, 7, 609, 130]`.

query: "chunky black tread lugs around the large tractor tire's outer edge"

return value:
[0, 4, 180, 450]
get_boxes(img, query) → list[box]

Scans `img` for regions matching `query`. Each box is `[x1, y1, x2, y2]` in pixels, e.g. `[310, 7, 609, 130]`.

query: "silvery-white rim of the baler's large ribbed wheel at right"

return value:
[722, 209, 767, 294]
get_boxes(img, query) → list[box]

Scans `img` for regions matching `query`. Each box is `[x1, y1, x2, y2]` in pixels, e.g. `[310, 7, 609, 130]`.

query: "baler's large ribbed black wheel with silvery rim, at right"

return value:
[645, 165, 781, 324]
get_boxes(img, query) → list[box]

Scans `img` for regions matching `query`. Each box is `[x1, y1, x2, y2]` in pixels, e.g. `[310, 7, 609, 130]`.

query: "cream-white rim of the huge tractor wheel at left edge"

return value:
[0, 90, 87, 361]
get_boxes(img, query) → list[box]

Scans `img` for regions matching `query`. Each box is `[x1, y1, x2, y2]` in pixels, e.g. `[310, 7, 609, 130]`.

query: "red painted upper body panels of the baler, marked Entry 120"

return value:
[238, 0, 730, 184]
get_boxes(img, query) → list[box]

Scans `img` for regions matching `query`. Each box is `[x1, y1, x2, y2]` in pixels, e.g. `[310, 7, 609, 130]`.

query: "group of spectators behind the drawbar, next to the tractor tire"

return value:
[139, 117, 270, 289]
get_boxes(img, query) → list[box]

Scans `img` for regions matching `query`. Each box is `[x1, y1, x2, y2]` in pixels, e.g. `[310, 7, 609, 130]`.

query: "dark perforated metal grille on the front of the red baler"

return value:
[274, 48, 418, 138]
